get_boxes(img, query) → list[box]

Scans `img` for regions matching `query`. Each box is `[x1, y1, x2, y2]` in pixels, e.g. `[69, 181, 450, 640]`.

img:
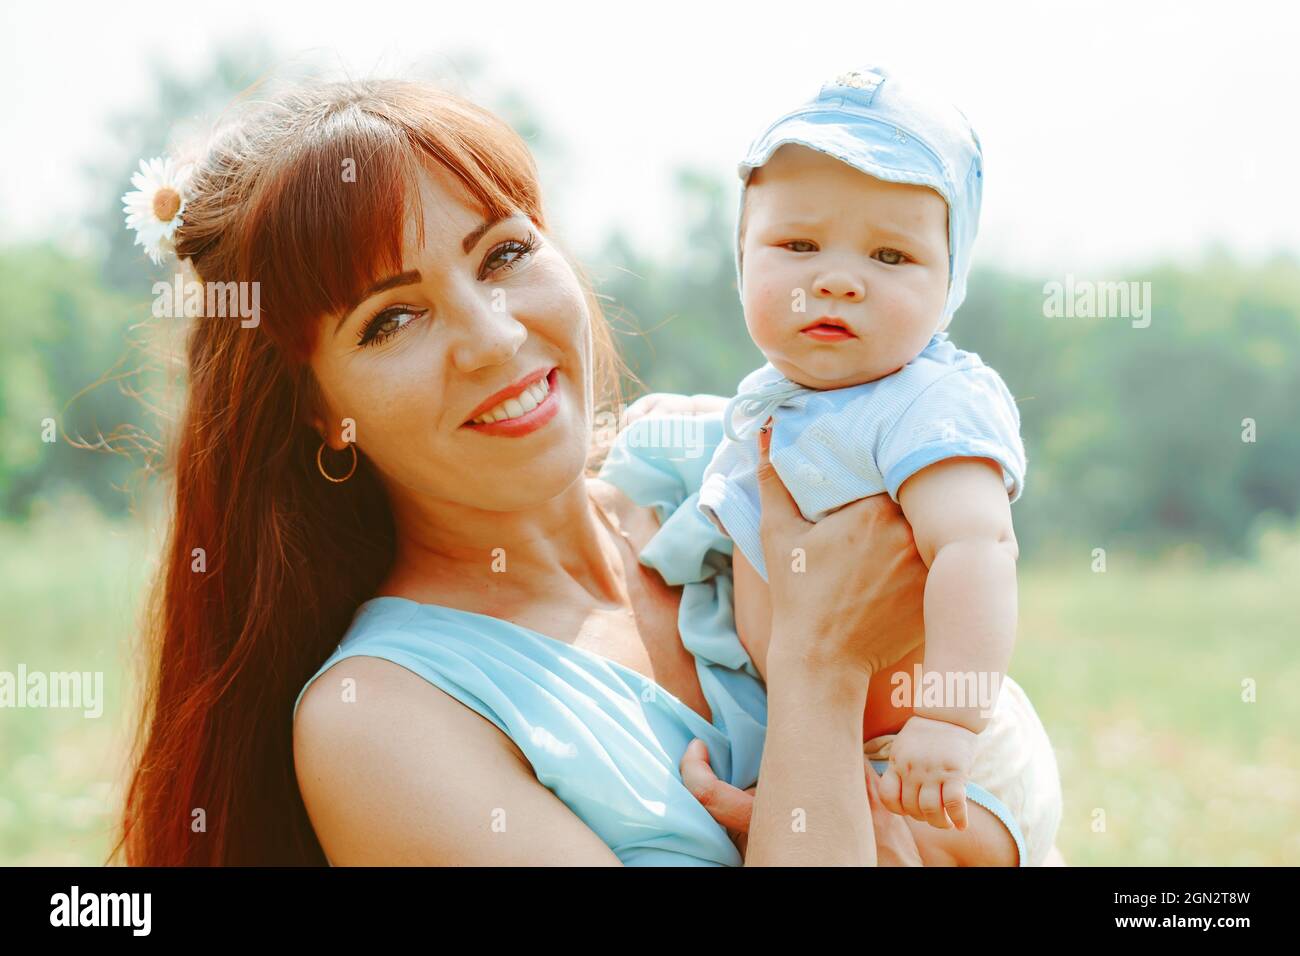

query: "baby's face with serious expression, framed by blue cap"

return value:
[742, 144, 948, 389]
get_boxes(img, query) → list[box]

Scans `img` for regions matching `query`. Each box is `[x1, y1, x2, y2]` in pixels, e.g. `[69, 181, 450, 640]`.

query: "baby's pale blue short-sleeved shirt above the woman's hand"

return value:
[698, 332, 1026, 580]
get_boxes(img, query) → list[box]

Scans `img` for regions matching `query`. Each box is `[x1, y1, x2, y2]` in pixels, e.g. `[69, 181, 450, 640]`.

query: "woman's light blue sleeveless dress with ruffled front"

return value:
[294, 414, 767, 866]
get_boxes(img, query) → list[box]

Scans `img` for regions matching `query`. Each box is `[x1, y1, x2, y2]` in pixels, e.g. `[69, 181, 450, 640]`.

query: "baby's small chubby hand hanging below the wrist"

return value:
[880, 714, 979, 830]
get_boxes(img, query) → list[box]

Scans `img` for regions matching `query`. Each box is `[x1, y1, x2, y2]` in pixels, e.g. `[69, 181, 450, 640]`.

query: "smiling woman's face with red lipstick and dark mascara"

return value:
[311, 162, 592, 511]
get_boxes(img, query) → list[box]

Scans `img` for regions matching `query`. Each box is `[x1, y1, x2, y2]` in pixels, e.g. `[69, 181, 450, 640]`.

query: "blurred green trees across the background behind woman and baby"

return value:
[0, 44, 1300, 564]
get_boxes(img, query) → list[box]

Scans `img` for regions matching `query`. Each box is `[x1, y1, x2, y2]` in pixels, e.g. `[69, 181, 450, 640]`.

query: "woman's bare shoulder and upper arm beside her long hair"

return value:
[294, 657, 620, 866]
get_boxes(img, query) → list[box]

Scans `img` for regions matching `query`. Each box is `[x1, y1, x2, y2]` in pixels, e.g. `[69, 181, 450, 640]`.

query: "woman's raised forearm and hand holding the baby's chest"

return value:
[728, 428, 926, 866]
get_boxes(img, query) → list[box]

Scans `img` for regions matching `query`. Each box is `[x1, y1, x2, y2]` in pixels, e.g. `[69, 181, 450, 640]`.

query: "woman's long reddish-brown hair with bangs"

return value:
[111, 81, 623, 866]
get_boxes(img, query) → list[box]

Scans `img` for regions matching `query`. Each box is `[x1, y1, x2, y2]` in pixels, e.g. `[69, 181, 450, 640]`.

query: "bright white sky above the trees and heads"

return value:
[0, 0, 1300, 278]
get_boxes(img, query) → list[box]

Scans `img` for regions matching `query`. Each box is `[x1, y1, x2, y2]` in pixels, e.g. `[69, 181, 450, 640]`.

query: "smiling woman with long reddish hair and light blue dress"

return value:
[120, 82, 1034, 865]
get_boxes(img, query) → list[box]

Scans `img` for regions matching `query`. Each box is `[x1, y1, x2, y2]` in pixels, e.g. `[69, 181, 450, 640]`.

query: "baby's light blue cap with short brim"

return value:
[736, 66, 984, 324]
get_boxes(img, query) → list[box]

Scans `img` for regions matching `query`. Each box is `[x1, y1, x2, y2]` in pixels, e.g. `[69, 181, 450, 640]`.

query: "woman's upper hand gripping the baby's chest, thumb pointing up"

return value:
[758, 421, 927, 680]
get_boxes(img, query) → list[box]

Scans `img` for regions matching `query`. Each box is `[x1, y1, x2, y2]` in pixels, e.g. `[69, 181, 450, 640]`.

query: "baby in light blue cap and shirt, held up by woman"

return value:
[699, 68, 1061, 865]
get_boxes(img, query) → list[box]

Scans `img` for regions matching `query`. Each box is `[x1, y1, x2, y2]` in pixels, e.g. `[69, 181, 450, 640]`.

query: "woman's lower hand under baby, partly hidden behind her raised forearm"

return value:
[681, 737, 922, 866]
